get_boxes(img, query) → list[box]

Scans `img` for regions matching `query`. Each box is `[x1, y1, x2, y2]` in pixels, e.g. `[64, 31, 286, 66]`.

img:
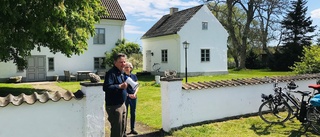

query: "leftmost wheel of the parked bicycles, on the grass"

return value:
[259, 100, 291, 124]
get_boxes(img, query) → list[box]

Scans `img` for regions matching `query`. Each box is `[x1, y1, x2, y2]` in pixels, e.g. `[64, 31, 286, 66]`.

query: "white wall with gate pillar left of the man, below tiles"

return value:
[0, 83, 105, 137]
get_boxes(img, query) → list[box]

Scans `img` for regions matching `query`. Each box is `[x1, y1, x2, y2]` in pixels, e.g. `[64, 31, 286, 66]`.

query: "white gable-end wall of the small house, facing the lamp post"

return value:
[178, 6, 228, 73]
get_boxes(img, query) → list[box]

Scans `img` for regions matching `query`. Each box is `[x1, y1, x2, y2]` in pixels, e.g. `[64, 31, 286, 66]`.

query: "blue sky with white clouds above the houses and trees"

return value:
[118, 0, 320, 46]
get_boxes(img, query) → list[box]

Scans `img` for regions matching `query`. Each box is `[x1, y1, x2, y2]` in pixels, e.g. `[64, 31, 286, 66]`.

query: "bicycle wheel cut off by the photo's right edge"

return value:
[307, 107, 320, 135]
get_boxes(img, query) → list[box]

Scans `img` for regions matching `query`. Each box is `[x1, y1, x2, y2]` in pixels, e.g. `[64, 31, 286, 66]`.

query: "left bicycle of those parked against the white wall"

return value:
[259, 80, 311, 124]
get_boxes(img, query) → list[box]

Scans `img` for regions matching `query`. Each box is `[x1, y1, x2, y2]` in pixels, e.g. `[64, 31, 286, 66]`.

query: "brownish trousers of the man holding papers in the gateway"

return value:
[106, 103, 127, 137]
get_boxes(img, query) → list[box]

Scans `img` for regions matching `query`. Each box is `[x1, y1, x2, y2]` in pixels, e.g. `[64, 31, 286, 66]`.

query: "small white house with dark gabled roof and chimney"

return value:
[141, 5, 228, 76]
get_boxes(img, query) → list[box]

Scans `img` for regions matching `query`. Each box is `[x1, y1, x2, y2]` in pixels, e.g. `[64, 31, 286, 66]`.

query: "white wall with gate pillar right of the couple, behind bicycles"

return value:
[160, 79, 316, 132]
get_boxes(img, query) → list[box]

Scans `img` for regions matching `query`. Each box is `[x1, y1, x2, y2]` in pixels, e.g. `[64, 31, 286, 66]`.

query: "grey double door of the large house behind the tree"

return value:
[27, 56, 47, 81]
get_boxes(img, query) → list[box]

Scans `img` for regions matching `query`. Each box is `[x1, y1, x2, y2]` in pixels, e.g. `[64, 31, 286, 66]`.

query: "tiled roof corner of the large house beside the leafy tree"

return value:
[101, 0, 127, 20]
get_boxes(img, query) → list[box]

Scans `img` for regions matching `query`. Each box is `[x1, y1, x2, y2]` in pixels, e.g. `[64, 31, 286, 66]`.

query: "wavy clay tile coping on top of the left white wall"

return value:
[0, 90, 83, 107]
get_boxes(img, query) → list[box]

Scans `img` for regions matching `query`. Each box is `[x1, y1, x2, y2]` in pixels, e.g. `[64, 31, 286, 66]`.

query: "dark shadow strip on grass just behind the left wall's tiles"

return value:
[0, 87, 46, 97]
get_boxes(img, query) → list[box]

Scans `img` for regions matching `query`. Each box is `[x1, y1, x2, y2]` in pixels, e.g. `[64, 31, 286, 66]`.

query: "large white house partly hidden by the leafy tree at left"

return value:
[0, 0, 126, 81]
